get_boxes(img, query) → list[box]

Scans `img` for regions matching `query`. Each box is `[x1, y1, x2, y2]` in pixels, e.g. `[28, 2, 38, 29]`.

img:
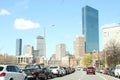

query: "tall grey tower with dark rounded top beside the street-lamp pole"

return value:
[36, 36, 46, 57]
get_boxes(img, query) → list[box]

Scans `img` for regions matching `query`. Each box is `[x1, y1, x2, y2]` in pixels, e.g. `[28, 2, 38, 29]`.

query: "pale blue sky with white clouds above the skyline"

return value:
[0, 0, 120, 58]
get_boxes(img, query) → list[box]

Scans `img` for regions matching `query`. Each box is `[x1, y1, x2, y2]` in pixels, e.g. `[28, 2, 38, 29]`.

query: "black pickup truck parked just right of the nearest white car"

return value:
[23, 64, 47, 80]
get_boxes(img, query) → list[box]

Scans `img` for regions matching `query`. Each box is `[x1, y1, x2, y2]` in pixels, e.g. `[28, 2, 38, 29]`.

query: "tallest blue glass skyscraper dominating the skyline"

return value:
[82, 6, 99, 53]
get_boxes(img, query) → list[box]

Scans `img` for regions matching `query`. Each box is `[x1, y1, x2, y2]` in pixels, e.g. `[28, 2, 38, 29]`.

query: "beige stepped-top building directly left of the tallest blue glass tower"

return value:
[74, 35, 85, 59]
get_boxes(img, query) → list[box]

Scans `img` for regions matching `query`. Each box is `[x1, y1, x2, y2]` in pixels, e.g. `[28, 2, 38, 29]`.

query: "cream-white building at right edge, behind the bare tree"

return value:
[102, 23, 120, 49]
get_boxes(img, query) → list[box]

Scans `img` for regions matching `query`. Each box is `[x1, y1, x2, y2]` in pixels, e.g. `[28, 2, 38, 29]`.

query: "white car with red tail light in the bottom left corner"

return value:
[0, 65, 27, 80]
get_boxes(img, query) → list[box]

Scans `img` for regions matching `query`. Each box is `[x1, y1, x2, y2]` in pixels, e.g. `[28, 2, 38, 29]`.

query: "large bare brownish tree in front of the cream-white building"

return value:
[105, 39, 120, 67]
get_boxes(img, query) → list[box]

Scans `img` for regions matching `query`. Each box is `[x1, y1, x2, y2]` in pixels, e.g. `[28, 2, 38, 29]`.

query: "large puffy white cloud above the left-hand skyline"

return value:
[14, 18, 40, 30]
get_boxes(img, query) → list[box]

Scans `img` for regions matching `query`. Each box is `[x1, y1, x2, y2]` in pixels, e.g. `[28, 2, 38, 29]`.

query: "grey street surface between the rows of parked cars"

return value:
[50, 71, 120, 80]
